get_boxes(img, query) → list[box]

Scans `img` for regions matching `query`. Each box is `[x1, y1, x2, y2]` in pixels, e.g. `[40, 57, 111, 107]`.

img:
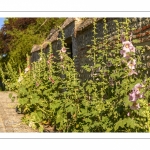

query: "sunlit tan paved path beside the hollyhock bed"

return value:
[0, 92, 37, 133]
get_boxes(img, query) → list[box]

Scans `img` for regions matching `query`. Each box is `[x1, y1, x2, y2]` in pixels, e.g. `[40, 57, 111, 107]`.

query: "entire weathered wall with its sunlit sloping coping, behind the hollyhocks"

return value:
[31, 18, 150, 78]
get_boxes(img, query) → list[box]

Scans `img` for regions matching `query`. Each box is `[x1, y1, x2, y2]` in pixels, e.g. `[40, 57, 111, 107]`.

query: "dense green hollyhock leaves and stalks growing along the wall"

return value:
[1, 18, 150, 132]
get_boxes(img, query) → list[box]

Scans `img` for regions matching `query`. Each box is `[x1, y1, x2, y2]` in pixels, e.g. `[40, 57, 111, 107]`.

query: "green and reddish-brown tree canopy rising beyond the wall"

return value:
[0, 18, 65, 69]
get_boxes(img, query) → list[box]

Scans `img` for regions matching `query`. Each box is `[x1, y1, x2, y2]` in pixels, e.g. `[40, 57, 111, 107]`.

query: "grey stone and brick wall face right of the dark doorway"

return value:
[72, 18, 150, 79]
